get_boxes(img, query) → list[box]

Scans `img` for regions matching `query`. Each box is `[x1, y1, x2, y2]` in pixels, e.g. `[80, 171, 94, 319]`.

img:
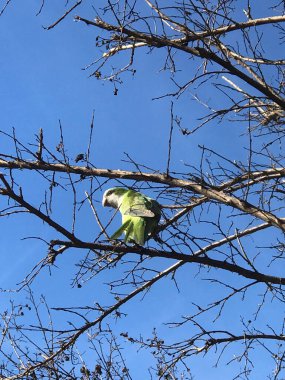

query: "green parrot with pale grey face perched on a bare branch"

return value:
[102, 187, 161, 245]
